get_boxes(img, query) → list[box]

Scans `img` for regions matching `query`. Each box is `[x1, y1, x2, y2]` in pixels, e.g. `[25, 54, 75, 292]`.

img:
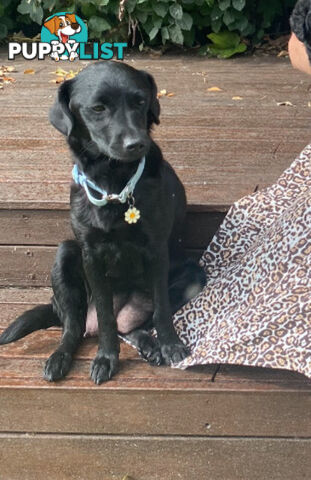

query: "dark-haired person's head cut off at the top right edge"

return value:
[290, 0, 311, 62]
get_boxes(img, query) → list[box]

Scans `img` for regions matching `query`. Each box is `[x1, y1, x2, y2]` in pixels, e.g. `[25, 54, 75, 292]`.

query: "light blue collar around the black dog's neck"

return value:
[72, 157, 146, 207]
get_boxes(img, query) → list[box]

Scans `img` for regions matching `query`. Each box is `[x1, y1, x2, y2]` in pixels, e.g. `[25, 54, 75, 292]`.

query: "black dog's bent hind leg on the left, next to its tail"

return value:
[44, 240, 87, 381]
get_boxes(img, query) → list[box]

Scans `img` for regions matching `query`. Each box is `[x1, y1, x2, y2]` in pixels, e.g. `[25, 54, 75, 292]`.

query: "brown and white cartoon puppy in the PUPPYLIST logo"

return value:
[43, 13, 81, 62]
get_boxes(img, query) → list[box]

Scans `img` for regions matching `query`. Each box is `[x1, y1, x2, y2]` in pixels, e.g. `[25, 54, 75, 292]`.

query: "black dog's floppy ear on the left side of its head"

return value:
[49, 80, 74, 137]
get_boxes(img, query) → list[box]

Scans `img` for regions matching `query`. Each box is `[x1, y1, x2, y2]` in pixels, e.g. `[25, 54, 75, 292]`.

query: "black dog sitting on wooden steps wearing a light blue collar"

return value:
[0, 62, 205, 384]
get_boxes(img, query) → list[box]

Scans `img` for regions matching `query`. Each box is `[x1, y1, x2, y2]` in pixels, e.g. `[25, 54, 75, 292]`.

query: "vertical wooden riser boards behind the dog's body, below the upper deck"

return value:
[0, 209, 225, 287]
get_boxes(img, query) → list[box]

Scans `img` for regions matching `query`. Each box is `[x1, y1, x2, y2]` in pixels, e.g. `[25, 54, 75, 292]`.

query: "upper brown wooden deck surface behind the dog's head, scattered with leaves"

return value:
[0, 53, 310, 210]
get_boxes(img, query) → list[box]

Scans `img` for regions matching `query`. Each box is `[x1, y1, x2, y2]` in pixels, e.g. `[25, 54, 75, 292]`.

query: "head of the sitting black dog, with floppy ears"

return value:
[49, 61, 160, 162]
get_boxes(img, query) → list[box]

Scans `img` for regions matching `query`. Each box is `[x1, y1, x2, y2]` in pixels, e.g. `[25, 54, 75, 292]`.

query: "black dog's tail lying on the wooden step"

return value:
[0, 304, 61, 345]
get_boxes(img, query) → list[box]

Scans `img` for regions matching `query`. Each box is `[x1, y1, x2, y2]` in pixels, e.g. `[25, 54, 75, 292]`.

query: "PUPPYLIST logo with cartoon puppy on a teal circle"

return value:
[8, 12, 127, 62]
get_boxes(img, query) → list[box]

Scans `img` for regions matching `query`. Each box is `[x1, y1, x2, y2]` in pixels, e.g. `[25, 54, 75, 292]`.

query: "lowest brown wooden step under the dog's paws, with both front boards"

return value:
[0, 288, 311, 480]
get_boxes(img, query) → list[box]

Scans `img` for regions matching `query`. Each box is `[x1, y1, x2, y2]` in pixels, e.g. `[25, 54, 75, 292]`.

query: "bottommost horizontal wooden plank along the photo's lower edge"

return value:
[0, 434, 311, 480]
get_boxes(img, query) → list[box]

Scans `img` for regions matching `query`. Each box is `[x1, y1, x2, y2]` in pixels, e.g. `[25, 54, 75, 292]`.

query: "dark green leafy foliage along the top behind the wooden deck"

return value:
[0, 0, 296, 58]
